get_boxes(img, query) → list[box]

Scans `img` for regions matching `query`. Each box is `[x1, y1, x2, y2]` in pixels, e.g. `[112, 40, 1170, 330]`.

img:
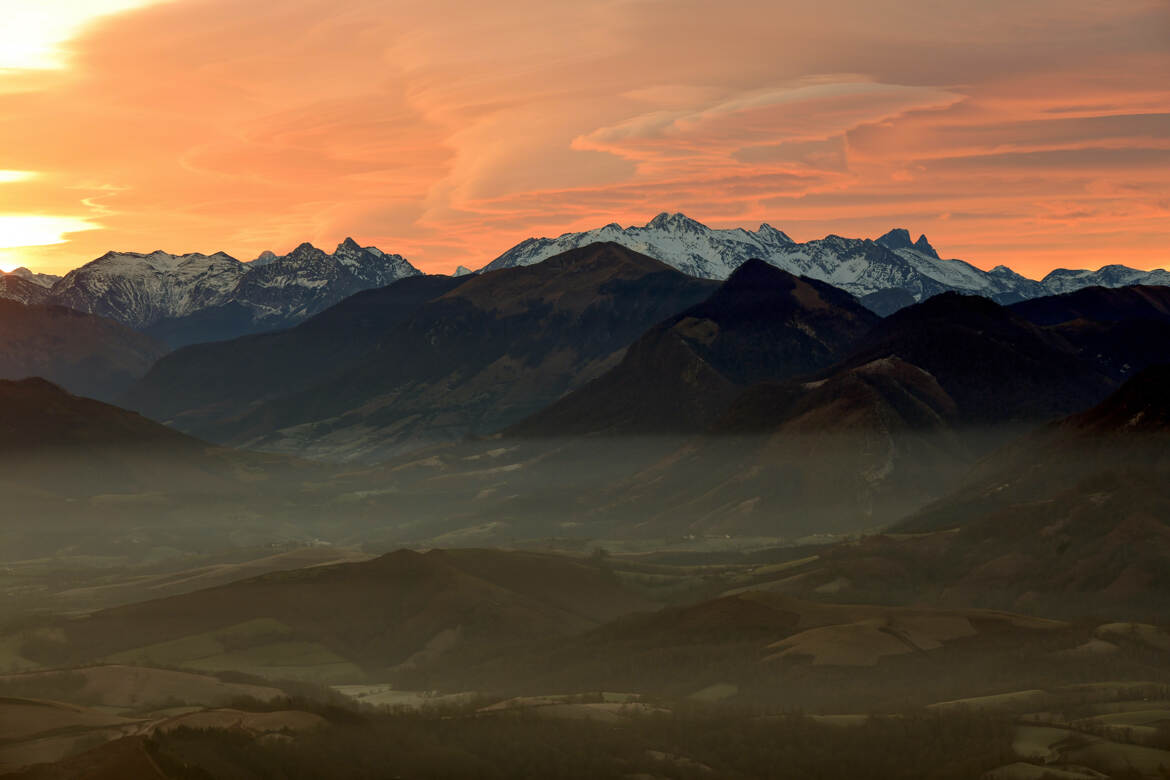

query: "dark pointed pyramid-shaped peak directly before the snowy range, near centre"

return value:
[509, 260, 878, 436]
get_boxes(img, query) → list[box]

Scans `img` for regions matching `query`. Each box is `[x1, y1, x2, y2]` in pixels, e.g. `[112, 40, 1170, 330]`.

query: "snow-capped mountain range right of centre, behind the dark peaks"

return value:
[480, 213, 1170, 315]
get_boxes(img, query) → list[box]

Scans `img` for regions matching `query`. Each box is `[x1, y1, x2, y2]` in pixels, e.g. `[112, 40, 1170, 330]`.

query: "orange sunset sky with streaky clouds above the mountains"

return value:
[0, 0, 1170, 276]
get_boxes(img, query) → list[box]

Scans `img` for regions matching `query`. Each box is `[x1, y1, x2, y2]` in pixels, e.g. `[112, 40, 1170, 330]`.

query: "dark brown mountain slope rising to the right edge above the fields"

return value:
[762, 366, 1170, 620]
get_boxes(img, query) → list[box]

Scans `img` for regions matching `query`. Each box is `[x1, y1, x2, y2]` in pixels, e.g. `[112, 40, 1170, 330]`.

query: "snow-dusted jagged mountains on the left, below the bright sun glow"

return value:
[8, 239, 420, 341]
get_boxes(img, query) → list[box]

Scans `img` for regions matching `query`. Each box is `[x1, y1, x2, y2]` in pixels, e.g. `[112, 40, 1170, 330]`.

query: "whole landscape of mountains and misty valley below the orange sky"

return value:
[0, 226, 1170, 780]
